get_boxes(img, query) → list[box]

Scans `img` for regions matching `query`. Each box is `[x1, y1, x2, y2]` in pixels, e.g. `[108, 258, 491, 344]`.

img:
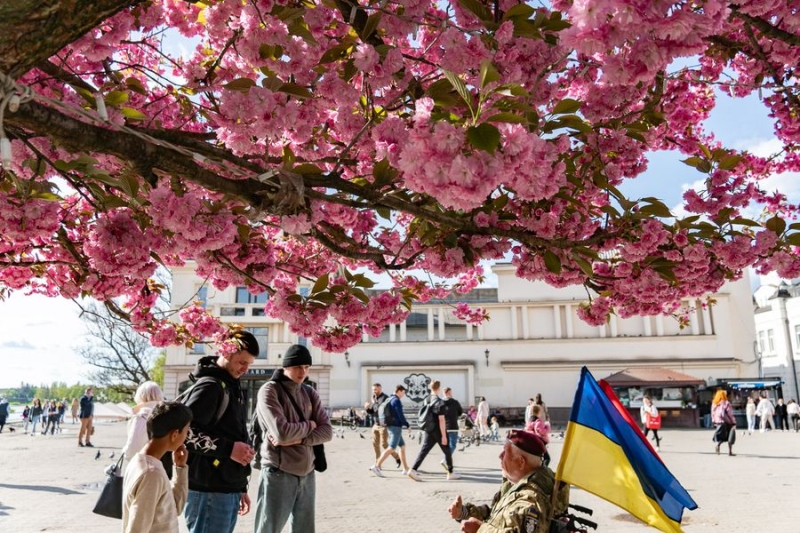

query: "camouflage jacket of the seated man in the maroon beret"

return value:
[463, 466, 569, 533]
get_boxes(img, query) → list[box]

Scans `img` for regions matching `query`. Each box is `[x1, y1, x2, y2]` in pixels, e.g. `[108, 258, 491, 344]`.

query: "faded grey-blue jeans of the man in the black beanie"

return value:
[255, 466, 317, 533]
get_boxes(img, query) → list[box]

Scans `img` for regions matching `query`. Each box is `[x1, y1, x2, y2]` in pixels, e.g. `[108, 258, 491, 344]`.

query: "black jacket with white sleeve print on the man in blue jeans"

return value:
[185, 356, 250, 493]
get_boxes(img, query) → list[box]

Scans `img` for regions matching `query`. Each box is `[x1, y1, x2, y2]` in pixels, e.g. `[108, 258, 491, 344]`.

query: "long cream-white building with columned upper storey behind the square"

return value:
[164, 264, 757, 420]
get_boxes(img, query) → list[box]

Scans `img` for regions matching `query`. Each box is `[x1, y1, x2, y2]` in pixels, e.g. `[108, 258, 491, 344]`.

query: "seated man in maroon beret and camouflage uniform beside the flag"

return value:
[450, 430, 569, 533]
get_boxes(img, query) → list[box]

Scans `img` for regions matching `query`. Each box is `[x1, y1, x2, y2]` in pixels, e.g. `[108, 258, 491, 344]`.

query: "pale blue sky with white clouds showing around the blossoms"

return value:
[0, 82, 800, 388]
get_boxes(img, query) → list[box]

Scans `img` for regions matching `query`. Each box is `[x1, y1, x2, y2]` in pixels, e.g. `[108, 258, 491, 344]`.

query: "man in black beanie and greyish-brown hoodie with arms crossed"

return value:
[255, 344, 333, 533]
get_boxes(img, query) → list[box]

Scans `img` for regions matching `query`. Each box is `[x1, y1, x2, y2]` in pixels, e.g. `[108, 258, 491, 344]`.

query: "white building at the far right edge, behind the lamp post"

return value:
[754, 274, 800, 400]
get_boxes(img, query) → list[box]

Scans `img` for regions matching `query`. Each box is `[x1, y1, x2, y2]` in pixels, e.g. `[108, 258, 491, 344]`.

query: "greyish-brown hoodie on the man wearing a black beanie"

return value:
[256, 369, 333, 476]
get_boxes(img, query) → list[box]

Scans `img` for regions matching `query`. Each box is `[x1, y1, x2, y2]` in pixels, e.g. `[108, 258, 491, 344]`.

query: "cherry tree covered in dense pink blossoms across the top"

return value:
[0, 0, 800, 351]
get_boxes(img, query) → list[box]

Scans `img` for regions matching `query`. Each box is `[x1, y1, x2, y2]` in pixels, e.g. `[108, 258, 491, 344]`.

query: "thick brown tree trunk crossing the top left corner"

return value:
[0, 0, 138, 78]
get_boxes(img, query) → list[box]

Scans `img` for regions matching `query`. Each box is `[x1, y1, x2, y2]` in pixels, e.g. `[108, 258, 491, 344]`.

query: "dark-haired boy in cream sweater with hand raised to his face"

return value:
[122, 402, 192, 533]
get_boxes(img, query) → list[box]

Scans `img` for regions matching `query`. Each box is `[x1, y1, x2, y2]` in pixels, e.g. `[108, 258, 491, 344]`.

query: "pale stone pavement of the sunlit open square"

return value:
[0, 423, 800, 533]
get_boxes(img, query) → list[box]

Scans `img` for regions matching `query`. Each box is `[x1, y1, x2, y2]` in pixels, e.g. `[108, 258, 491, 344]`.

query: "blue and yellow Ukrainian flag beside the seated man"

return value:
[556, 367, 697, 532]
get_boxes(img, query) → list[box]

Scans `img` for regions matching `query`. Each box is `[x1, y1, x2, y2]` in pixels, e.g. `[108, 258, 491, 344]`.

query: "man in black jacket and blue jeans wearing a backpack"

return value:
[184, 331, 258, 533]
